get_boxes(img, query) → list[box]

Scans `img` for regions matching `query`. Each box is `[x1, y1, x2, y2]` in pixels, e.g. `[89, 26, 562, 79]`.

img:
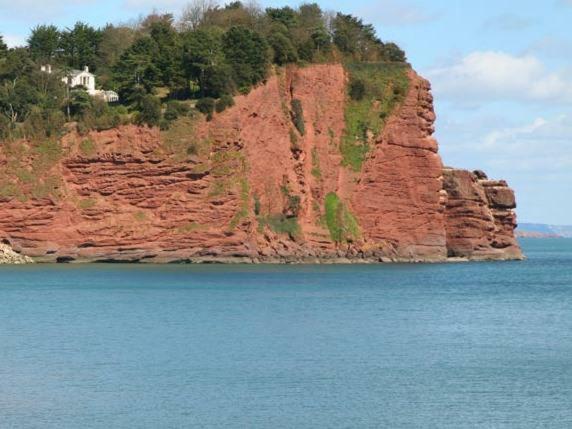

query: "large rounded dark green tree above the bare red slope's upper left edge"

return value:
[223, 27, 270, 88]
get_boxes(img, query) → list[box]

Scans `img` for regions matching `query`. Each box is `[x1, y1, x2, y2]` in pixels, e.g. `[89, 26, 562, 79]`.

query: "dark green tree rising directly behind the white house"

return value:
[60, 22, 101, 69]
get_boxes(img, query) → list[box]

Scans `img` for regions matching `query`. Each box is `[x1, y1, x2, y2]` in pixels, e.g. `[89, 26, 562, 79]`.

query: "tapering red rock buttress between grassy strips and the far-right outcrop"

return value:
[352, 71, 447, 260]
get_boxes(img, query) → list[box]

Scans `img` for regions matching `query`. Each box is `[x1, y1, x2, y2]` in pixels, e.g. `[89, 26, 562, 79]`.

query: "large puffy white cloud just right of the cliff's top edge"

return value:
[427, 51, 572, 104]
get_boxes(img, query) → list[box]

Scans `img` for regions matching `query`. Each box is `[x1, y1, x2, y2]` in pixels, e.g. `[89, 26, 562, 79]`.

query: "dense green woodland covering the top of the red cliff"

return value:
[0, 0, 406, 139]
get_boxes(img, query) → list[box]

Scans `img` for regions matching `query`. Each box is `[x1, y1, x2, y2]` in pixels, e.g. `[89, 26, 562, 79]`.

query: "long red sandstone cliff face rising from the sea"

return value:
[0, 65, 521, 262]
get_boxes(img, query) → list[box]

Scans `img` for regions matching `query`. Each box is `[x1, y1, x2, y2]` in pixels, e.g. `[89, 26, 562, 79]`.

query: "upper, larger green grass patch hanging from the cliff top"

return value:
[340, 63, 409, 171]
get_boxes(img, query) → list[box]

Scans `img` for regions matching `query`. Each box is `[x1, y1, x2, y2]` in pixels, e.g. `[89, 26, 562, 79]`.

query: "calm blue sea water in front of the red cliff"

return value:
[0, 240, 572, 429]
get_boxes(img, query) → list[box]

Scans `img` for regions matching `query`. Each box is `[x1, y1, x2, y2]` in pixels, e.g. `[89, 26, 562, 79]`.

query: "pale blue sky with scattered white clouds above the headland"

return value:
[0, 0, 572, 225]
